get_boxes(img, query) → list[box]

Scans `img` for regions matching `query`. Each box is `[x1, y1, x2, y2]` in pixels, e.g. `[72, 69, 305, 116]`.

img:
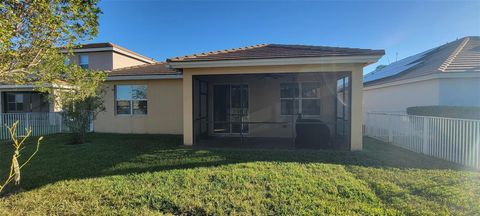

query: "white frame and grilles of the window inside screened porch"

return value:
[280, 81, 322, 117]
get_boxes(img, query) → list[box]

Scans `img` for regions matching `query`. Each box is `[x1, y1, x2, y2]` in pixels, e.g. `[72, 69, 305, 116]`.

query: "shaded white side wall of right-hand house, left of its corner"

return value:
[363, 80, 439, 113]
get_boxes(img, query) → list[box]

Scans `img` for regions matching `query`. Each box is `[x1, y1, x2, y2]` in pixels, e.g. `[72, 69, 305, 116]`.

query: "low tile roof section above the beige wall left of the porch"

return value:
[108, 62, 177, 77]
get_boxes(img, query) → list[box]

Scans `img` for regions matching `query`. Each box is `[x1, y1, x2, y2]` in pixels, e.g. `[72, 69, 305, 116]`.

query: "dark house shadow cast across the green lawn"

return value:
[0, 134, 465, 190]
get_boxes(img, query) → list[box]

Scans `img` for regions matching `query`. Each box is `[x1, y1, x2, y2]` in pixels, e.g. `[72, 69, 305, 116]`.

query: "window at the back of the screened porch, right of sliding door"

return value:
[280, 82, 320, 115]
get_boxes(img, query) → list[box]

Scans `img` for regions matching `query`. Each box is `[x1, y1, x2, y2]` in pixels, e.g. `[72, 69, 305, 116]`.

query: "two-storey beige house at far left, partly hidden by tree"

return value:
[0, 43, 155, 113]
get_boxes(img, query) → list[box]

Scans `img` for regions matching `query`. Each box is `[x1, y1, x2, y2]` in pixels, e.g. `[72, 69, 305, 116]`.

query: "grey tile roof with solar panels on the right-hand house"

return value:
[364, 36, 480, 86]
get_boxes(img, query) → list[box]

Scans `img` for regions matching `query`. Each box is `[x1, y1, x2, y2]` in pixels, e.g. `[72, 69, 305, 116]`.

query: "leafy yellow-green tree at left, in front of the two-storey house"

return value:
[0, 0, 106, 142]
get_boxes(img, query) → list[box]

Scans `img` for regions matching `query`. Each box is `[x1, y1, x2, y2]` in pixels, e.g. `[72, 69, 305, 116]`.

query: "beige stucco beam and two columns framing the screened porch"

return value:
[183, 64, 363, 150]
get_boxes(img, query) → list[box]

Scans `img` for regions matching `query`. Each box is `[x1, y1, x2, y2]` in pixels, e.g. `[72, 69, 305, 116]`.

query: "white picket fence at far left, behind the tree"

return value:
[0, 112, 93, 140]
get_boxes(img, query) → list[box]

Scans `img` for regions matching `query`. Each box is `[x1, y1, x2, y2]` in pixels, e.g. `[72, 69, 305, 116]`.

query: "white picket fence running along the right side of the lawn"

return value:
[365, 113, 480, 169]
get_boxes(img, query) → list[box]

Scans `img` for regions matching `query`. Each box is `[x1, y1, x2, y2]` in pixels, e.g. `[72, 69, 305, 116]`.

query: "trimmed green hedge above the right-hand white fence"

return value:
[407, 106, 480, 120]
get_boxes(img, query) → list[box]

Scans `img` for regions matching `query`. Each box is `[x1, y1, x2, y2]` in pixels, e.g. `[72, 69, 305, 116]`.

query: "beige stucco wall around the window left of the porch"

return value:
[94, 79, 183, 134]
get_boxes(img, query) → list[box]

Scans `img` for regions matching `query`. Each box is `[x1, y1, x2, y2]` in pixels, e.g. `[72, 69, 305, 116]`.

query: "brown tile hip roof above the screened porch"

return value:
[167, 44, 385, 62]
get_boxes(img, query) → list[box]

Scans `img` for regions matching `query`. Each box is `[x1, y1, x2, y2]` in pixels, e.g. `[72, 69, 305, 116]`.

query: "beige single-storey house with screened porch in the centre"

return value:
[95, 44, 384, 150]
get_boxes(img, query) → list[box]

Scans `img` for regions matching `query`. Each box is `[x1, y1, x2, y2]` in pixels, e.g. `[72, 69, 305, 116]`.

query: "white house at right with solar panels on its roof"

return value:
[363, 36, 480, 113]
